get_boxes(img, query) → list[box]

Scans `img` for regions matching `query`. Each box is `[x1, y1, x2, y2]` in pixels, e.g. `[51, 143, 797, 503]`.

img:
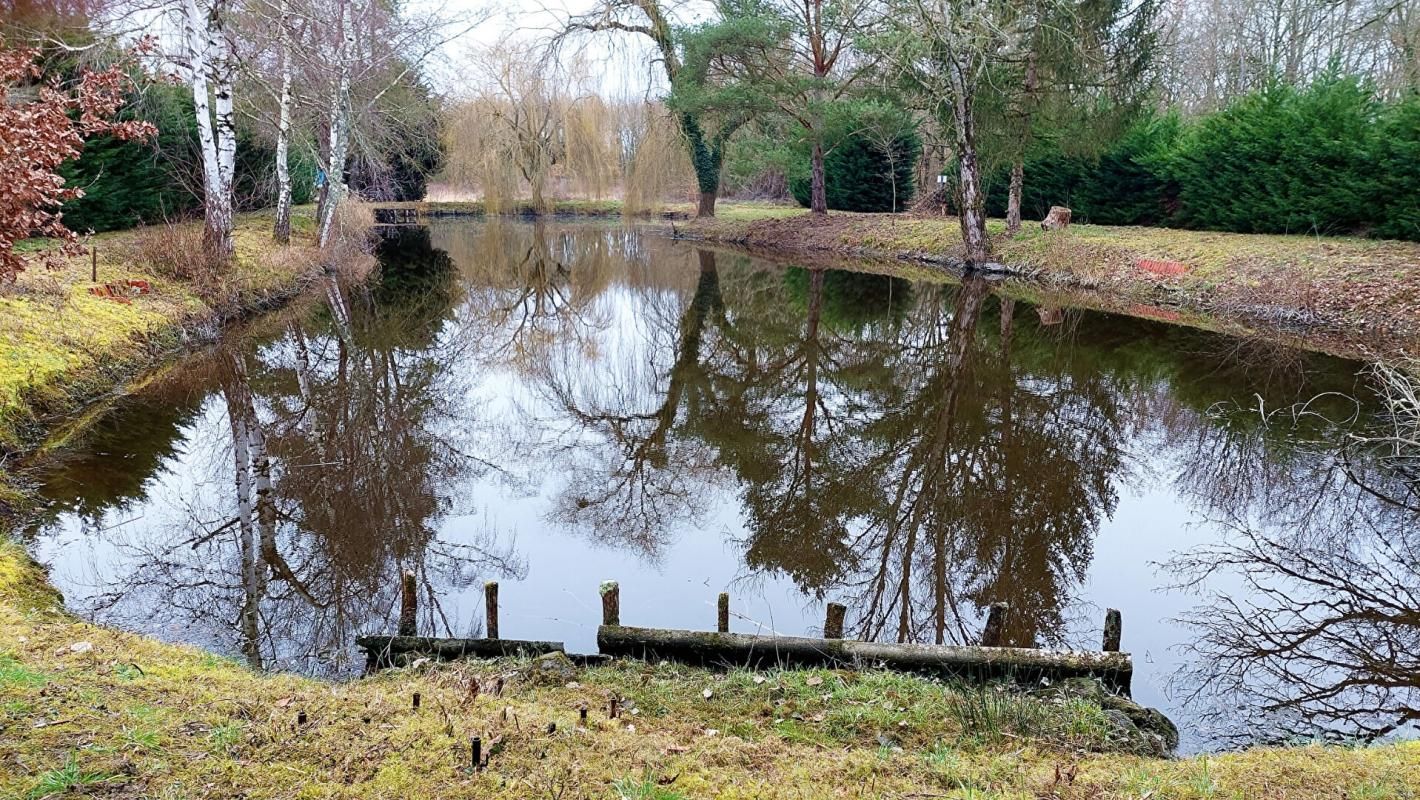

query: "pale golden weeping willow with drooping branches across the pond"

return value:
[444, 45, 689, 212]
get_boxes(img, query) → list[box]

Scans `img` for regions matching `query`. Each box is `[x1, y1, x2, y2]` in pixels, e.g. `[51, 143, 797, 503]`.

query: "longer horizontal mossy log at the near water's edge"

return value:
[596, 625, 1135, 695]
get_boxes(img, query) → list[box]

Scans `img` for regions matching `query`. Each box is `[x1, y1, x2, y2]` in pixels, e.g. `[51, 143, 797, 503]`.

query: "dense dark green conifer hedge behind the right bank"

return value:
[988, 75, 1420, 240]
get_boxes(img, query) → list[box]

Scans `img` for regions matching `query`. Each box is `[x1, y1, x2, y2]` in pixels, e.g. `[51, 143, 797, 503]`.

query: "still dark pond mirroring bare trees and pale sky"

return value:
[27, 222, 1420, 749]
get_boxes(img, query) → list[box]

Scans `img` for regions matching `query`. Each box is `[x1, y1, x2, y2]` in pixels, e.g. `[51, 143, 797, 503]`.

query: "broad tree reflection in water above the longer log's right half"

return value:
[829, 280, 1125, 645]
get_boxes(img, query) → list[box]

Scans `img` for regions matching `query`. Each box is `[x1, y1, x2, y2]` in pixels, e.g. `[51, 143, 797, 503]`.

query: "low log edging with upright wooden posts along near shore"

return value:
[356, 577, 1133, 696]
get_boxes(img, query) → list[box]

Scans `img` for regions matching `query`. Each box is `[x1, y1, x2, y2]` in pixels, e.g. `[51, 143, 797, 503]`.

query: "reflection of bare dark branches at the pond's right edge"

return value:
[1170, 375, 1420, 740]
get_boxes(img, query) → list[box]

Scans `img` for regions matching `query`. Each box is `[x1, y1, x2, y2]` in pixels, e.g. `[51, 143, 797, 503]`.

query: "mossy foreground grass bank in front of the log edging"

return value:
[0, 544, 1420, 800]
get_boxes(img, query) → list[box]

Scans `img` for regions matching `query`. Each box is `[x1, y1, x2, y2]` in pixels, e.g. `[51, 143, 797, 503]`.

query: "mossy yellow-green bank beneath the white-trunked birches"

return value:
[0, 207, 342, 514]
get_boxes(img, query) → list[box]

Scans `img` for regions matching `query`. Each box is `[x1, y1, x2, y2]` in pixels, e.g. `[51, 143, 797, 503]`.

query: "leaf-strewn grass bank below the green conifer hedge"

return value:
[676, 207, 1420, 358]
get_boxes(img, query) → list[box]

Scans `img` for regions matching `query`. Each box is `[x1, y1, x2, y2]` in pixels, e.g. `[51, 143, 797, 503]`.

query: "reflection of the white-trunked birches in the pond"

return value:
[88, 228, 521, 669]
